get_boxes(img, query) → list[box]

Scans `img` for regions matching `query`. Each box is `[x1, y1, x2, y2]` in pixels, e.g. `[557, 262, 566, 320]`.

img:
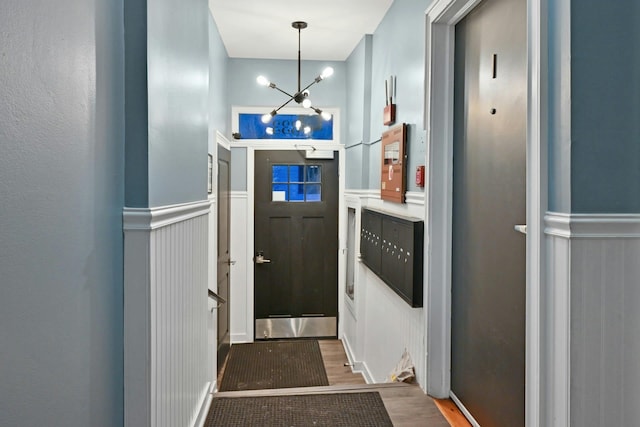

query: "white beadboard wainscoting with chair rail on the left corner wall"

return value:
[124, 201, 211, 427]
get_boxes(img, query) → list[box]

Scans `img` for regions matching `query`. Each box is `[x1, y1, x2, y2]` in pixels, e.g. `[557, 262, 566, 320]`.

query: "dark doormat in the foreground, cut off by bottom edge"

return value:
[205, 392, 393, 427]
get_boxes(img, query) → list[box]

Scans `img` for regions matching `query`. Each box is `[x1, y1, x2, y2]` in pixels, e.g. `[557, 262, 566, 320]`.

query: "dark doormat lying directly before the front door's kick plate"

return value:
[220, 340, 329, 391]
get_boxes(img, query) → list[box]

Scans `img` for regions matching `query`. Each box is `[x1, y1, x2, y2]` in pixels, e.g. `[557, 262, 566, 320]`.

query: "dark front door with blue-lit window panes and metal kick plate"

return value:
[254, 151, 338, 339]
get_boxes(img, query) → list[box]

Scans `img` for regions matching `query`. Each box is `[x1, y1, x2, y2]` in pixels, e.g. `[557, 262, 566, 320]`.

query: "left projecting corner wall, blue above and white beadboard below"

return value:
[123, 0, 215, 426]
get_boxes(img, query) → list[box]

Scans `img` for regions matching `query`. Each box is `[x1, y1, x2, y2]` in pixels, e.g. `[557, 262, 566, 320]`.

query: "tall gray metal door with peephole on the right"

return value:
[451, 0, 527, 427]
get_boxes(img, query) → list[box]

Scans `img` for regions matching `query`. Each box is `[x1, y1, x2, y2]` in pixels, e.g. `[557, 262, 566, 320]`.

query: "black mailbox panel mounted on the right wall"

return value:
[360, 209, 424, 307]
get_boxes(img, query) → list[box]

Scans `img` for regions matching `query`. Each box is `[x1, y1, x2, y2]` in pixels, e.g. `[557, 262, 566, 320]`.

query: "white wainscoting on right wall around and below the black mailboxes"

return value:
[340, 190, 426, 388]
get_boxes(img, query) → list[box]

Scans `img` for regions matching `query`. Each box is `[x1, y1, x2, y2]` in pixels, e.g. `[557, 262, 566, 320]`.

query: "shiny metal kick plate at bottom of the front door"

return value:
[256, 317, 338, 340]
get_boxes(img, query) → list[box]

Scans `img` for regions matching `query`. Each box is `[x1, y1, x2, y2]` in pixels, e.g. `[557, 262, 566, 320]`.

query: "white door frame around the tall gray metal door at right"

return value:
[424, 0, 547, 426]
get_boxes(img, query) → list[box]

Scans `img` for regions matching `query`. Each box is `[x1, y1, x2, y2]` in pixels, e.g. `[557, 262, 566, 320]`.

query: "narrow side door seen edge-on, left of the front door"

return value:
[217, 146, 231, 372]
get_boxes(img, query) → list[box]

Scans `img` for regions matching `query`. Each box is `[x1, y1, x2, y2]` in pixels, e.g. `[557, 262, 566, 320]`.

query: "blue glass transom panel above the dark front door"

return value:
[238, 113, 333, 141]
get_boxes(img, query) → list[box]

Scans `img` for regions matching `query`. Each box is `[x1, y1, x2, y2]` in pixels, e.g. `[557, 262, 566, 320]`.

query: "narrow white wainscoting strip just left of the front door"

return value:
[230, 191, 253, 343]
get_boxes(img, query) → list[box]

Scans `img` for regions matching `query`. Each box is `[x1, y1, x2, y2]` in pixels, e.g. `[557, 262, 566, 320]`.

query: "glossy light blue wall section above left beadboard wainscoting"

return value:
[147, 0, 209, 206]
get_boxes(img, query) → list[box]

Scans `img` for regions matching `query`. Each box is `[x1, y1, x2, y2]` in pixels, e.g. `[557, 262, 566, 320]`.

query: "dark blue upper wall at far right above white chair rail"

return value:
[571, 0, 640, 213]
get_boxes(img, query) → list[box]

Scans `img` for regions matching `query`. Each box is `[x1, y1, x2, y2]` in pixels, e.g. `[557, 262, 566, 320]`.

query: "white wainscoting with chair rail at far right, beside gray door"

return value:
[542, 213, 640, 426]
